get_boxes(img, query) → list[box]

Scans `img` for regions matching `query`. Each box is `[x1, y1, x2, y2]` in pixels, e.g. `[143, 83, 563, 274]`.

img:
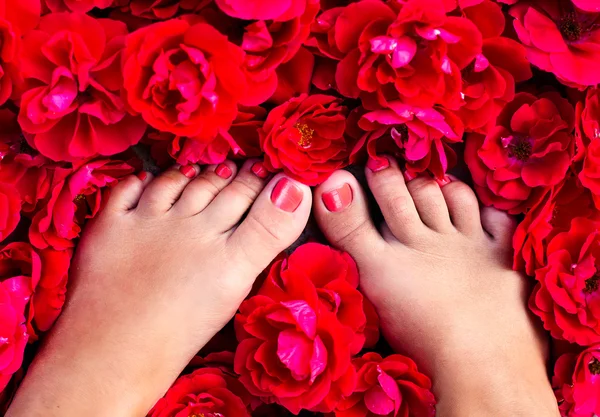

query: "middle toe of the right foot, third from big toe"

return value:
[407, 176, 455, 233]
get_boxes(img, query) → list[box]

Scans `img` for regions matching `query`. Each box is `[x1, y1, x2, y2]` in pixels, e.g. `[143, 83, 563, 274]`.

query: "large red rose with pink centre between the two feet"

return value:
[235, 244, 376, 414]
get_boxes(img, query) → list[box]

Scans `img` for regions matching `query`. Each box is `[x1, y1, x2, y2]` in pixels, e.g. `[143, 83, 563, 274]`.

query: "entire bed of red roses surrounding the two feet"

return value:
[0, 0, 600, 417]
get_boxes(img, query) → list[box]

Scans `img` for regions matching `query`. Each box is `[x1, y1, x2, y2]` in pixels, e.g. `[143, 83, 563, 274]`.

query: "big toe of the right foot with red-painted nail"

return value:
[313, 171, 384, 259]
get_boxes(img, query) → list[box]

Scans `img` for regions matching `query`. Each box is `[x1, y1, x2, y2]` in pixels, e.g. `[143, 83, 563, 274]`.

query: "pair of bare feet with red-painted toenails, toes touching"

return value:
[8, 159, 558, 416]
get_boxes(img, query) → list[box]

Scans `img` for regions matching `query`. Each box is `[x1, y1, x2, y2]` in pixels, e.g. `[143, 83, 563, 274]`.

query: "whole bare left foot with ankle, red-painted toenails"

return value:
[7, 161, 312, 417]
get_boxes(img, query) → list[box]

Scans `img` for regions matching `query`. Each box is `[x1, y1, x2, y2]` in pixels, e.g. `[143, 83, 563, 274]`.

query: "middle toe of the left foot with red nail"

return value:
[173, 161, 237, 216]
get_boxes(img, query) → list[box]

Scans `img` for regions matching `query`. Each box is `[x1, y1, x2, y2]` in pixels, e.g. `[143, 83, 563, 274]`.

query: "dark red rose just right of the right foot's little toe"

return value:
[513, 177, 600, 275]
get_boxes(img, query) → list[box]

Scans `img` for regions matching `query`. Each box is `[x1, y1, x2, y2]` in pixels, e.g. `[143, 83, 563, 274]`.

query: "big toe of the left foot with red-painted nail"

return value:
[228, 174, 312, 274]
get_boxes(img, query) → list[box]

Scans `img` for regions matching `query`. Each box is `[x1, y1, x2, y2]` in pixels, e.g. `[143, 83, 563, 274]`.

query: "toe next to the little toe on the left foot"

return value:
[136, 165, 200, 214]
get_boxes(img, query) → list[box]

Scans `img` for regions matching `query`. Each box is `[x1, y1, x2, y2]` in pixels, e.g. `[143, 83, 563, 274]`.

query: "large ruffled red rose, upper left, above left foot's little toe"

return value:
[19, 13, 146, 161]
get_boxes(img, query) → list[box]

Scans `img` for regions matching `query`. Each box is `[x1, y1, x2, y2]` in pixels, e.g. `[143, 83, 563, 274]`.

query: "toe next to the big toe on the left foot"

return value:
[202, 160, 268, 232]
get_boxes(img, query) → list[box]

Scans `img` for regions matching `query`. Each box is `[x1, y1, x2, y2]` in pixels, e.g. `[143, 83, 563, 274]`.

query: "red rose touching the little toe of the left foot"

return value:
[29, 160, 135, 250]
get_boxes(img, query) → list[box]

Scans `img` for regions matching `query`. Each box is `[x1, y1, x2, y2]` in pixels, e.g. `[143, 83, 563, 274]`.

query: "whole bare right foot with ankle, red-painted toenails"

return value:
[313, 158, 559, 417]
